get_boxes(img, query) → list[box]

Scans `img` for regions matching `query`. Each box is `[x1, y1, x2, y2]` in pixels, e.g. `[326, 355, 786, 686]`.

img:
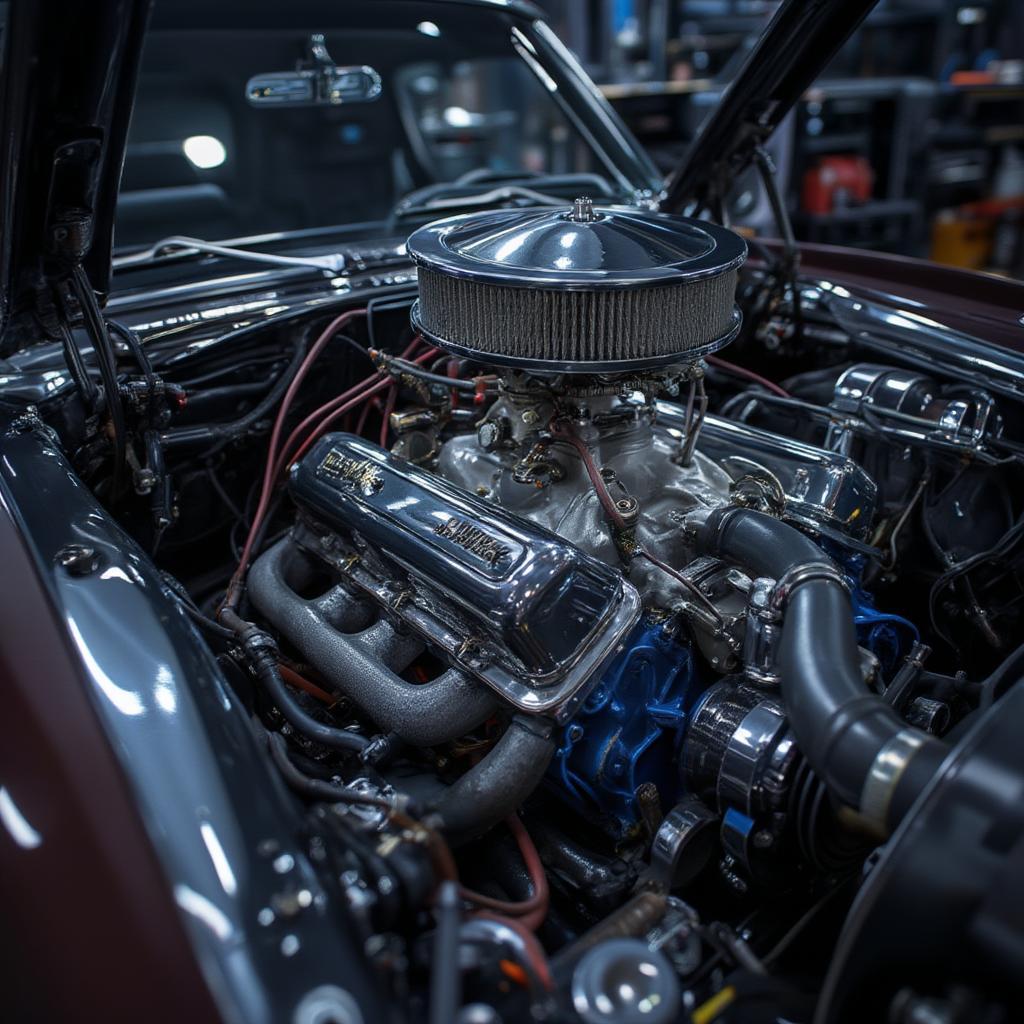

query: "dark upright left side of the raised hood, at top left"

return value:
[0, 0, 150, 354]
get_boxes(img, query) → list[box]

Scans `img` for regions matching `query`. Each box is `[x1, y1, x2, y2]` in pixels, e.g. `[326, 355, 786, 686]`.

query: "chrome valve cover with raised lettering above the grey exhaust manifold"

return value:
[291, 434, 640, 715]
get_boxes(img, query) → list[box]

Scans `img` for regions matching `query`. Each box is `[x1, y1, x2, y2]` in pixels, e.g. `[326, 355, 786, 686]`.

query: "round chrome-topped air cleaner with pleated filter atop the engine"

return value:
[408, 199, 746, 374]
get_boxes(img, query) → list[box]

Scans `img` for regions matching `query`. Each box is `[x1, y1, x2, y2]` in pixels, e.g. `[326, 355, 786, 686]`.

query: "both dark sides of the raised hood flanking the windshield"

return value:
[0, 0, 874, 355]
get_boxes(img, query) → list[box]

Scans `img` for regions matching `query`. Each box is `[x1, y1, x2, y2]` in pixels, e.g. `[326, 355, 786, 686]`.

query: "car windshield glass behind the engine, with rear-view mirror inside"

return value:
[116, 0, 656, 249]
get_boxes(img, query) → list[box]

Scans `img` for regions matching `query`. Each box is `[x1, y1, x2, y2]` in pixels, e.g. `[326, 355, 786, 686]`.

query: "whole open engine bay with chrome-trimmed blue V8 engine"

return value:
[3, 198, 1024, 1024]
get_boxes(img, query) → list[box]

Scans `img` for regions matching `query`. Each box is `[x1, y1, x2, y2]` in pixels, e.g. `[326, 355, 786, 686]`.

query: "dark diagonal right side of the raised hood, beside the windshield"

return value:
[660, 0, 878, 211]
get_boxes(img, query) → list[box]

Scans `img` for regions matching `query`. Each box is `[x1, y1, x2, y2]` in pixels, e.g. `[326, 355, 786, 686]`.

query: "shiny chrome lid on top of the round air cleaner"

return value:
[408, 199, 746, 291]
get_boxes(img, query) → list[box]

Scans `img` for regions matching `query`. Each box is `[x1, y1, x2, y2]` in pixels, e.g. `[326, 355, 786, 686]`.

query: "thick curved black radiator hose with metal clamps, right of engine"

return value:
[697, 509, 946, 827]
